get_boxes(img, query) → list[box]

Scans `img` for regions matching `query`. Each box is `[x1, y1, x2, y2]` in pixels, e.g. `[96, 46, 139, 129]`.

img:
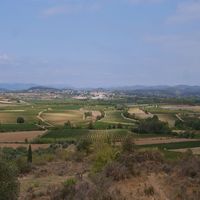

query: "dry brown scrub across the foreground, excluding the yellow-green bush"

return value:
[14, 142, 200, 200]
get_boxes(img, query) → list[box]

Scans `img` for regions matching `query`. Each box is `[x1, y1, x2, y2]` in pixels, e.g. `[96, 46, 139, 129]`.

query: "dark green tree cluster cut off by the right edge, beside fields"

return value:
[175, 117, 200, 130]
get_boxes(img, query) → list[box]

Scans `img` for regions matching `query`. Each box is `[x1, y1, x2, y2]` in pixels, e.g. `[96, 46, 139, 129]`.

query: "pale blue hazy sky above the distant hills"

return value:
[0, 0, 200, 87]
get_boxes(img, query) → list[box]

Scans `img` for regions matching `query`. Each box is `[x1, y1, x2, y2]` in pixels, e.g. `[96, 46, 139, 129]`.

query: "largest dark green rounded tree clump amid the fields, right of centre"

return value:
[134, 115, 171, 134]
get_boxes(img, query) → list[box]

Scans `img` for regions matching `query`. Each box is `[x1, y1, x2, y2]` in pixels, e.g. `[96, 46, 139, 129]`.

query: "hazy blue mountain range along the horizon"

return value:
[0, 83, 200, 97]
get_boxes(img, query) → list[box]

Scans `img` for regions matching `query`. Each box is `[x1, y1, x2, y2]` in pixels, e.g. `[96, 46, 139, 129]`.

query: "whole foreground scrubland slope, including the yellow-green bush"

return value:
[0, 136, 200, 200]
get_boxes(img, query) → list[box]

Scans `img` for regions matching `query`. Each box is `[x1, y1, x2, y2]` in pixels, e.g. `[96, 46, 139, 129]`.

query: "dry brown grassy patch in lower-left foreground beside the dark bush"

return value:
[19, 160, 89, 200]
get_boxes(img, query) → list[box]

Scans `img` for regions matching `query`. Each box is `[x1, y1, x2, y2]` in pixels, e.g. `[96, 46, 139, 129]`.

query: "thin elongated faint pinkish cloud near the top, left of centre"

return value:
[42, 3, 100, 17]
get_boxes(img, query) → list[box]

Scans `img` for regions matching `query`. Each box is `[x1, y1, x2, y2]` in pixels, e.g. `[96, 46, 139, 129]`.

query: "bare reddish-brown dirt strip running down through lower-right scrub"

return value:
[148, 174, 170, 200]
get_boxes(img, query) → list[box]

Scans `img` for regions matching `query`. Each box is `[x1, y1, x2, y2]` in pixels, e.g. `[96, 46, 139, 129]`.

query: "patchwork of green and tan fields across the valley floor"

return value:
[0, 102, 200, 153]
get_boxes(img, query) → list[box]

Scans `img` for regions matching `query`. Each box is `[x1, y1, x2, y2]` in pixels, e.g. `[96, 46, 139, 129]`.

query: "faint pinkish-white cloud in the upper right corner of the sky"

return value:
[167, 1, 200, 23]
